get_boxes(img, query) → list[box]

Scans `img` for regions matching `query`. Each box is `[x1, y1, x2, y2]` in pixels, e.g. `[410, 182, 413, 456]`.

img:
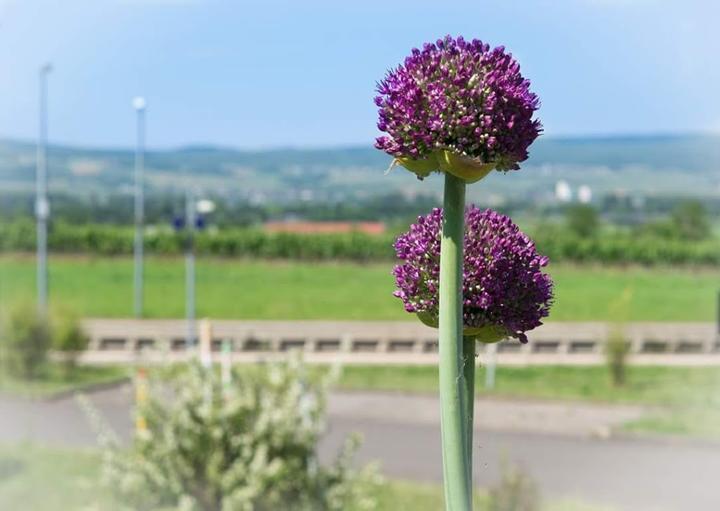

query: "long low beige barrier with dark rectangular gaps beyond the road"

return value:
[83, 319, 720, 365]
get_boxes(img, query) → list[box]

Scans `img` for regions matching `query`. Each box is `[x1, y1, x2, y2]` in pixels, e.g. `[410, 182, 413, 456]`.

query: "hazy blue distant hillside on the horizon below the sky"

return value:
[0, 135, 720, 201]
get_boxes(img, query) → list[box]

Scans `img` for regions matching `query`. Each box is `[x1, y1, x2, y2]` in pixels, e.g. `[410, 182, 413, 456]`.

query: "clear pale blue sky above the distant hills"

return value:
[0, 0, 720, 148]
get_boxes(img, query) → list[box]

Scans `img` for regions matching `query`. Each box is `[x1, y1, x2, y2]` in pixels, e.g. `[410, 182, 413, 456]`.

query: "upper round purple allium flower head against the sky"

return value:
[375, 36, 542, 177]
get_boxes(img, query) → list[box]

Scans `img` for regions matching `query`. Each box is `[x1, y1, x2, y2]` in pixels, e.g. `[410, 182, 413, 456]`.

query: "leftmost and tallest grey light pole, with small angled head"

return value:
[35, 63, 52, 315]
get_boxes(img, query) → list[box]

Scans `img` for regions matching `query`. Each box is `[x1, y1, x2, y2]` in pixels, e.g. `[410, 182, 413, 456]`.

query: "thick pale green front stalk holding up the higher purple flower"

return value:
[439, 172, 472, 511]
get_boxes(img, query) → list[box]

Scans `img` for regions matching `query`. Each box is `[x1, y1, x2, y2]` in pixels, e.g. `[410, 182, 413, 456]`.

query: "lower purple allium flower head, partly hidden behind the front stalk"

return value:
[393, 206, 553, 342]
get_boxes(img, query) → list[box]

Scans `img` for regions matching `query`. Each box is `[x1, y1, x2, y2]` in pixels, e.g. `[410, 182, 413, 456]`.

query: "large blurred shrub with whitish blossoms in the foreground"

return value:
[91, 362, 376, 511]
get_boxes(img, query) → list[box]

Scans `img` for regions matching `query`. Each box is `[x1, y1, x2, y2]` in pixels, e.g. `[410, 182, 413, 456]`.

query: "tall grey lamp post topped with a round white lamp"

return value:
[132, 96, 146, 318]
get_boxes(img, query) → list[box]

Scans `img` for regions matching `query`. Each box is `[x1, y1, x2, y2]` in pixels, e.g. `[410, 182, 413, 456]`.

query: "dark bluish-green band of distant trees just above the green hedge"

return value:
[0, 192, 720, 228]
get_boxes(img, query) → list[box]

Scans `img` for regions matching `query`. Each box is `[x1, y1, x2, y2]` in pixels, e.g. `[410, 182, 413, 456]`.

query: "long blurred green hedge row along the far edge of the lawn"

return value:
[0, 220, 720, 265]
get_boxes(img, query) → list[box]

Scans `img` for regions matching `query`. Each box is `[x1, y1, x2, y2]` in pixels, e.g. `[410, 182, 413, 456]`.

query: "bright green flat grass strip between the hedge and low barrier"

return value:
[0, 255, 720, 321]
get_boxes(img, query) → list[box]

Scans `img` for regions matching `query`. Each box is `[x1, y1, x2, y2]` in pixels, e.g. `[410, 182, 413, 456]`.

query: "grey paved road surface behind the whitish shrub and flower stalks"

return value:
[0, 387, 720, 511]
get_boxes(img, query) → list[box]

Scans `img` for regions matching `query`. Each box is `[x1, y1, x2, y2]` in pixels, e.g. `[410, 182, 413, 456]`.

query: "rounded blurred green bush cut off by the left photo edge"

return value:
[1, 304, 52, 379]
